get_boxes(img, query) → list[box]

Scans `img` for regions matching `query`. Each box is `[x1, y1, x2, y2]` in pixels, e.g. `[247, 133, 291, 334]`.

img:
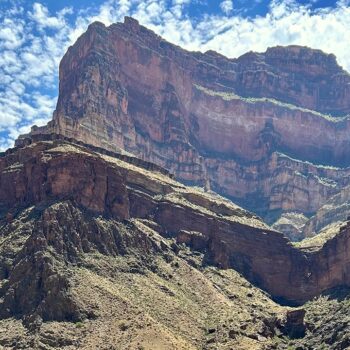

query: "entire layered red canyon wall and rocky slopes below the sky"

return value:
[0, 17, 350, 350]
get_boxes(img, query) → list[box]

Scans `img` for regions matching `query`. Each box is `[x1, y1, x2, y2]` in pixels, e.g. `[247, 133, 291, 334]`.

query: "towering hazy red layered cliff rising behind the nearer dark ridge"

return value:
[18, 18, 350, 235]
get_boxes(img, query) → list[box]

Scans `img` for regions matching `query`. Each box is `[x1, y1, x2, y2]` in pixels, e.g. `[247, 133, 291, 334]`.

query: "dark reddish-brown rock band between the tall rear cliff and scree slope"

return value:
[0, 135, 350, 306]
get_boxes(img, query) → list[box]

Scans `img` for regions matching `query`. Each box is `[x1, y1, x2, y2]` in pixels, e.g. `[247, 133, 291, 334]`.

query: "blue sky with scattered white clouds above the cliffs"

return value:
[0, 0, 350, 150]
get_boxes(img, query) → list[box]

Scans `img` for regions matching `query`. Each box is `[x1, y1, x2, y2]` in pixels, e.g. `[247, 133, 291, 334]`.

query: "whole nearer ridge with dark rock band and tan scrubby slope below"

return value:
[0, 135, 350, 349]
